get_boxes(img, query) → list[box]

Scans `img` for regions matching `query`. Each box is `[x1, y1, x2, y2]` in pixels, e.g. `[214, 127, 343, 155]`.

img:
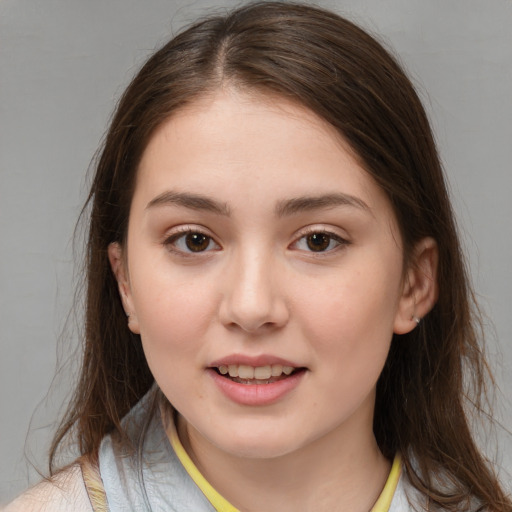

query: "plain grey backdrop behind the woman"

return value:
[0, 0, 512, 503]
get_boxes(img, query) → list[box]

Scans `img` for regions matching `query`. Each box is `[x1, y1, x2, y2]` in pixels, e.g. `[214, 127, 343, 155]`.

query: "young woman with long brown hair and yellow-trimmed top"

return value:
[8, 2, 512, 512]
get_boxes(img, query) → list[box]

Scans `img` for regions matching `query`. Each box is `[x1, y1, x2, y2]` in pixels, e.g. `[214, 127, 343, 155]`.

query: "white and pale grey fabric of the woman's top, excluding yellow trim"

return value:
[4, 390, 421, 512]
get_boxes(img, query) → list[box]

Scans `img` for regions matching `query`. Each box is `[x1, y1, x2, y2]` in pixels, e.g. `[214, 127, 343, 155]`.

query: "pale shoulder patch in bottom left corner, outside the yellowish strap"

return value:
[1, 464, 92, 512]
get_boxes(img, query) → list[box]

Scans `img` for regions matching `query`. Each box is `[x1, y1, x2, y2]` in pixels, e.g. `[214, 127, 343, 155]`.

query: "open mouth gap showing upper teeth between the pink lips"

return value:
[211, 364, 306, 385]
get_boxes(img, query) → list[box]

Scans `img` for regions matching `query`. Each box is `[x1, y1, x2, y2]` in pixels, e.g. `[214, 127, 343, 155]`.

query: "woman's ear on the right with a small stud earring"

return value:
[393, 237, 439, 334]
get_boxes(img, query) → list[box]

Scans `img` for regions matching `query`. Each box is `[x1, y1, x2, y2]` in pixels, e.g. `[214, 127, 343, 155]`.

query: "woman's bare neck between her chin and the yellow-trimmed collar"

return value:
[174, 417, 390, 512]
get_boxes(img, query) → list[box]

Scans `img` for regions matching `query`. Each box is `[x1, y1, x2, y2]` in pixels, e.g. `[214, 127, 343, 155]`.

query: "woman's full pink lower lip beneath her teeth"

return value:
[207, 368, 306, 406]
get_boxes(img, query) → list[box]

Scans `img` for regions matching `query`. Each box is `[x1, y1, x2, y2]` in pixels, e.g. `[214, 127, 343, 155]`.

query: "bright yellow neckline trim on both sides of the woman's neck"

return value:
[167, 421, 402, 512]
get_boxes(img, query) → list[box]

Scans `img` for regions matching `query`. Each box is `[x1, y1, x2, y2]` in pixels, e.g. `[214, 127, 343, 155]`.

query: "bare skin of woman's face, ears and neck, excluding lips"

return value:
[109, 89, 437, 511]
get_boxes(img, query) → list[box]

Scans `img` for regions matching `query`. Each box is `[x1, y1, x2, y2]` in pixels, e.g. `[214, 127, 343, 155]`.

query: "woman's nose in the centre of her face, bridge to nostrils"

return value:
[219, 251, 290, 334]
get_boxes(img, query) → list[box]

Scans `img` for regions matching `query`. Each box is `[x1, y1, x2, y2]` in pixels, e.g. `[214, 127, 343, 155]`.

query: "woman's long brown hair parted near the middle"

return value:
[50, 2, 512, 512]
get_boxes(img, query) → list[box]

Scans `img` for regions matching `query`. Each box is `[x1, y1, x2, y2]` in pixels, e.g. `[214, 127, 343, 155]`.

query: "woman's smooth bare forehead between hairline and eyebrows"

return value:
[135, 89, 392, 218]
